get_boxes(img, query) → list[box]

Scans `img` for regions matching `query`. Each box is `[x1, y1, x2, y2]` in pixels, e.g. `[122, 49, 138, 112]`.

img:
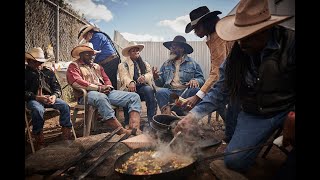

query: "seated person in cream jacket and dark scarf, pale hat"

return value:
[118, 42, 157, 124]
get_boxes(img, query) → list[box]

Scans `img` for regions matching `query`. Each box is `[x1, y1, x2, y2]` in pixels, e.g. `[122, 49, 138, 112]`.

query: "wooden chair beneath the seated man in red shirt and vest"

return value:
[71, 88, 119, 137]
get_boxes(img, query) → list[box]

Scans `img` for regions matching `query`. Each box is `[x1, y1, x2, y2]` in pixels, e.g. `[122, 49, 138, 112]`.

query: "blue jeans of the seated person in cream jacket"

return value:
[123, 85, 157, 124]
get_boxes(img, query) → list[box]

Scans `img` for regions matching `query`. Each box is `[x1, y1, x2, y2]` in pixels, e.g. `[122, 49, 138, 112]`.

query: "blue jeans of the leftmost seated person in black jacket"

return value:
[27, 98, 72, 134]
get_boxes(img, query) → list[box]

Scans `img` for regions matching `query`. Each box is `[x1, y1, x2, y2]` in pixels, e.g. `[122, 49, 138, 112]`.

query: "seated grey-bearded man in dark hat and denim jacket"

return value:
[152, 35, 204, 116]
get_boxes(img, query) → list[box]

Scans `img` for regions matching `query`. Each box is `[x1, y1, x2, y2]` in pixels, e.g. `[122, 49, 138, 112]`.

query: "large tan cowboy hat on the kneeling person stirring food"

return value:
[216, 0, 292, 41]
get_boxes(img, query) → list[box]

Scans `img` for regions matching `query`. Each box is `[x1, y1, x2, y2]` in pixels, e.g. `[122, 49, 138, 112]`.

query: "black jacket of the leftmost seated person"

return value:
[24, 66, 62, 102]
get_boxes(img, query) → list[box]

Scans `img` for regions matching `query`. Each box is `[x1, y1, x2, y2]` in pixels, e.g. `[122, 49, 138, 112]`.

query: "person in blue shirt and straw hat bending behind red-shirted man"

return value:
[78, 24, 121, 89]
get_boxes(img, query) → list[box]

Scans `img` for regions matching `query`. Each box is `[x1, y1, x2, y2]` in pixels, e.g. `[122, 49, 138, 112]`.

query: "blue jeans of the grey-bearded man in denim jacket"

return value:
[156, 88, 200, 116]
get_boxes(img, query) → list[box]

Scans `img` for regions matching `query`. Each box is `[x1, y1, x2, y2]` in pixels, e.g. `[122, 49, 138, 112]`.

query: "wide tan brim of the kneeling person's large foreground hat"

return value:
[216, 15, 293, 41]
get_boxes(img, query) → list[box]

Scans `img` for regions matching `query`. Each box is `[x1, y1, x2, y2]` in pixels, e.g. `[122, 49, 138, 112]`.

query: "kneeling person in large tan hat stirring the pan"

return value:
[174, 0, 296, 172]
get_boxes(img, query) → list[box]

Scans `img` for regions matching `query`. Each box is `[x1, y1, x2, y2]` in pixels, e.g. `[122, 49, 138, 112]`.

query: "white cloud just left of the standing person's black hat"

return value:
[157, 15, 190, 33]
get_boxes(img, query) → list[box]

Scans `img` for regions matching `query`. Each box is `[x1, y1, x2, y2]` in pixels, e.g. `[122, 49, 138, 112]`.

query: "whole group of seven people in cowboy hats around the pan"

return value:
[25, 0, 296, 177]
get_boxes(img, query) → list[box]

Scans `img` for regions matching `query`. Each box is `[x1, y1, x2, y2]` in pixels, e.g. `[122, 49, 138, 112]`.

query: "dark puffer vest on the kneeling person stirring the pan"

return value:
[230, 26, 296, 117]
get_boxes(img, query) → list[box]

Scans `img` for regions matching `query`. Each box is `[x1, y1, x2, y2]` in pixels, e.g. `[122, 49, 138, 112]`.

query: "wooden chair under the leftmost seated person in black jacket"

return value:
[25, 106, 77, 153]
